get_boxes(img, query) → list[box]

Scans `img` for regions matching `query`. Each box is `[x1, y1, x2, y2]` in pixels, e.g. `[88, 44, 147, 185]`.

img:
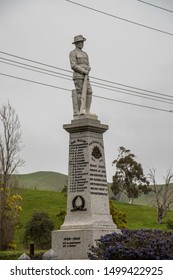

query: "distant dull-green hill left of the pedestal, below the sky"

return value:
[17, 171, 67, 192]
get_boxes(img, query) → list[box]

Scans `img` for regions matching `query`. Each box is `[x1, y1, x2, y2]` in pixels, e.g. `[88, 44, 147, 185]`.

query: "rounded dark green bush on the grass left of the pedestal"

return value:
[24, 212, 54, 249]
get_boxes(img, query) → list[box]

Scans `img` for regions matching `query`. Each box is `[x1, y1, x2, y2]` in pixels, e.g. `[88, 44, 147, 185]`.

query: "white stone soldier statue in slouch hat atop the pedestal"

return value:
[69, 35, 92, 115]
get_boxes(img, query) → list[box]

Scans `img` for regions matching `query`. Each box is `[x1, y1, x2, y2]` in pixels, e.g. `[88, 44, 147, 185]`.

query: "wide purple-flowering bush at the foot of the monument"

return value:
[89, 229, 173, 260]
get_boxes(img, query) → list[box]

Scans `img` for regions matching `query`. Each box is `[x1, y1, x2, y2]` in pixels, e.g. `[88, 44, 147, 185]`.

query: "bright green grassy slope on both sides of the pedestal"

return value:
[15, 189, 173, 249]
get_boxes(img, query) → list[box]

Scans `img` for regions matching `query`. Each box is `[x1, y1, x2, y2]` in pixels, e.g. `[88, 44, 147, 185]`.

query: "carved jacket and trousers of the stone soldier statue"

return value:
[69, 47, 92, 95]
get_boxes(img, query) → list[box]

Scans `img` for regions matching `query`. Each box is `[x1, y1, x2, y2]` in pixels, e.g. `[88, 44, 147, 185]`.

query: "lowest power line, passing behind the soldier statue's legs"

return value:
[0, 73, 173, 113]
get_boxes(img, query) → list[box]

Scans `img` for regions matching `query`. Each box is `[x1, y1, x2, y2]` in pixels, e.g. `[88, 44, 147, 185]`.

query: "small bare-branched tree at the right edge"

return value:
[148, 168, 173, 224]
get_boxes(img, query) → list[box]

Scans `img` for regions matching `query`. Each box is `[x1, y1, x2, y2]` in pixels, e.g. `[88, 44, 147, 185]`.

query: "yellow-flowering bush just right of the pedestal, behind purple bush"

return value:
[109, 201, 127, 229]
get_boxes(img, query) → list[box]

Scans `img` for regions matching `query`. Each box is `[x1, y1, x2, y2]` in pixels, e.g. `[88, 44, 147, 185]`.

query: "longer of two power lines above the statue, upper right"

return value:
[65, 0, 173, 36]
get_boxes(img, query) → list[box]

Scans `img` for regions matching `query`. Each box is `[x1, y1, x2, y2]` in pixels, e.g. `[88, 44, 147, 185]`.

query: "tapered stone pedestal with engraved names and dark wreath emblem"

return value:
[52, 115, 120, 259]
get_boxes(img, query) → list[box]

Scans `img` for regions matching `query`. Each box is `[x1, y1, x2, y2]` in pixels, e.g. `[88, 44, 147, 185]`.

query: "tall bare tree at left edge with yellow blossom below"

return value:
[0, 103, 23, 250]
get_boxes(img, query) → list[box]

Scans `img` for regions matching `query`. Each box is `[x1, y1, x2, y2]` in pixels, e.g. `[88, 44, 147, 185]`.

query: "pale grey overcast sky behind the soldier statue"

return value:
[0, 0, 173, 184]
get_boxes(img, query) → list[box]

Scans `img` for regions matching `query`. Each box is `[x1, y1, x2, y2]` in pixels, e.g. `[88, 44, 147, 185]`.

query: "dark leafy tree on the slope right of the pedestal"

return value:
[111, 147, 151, 204]
